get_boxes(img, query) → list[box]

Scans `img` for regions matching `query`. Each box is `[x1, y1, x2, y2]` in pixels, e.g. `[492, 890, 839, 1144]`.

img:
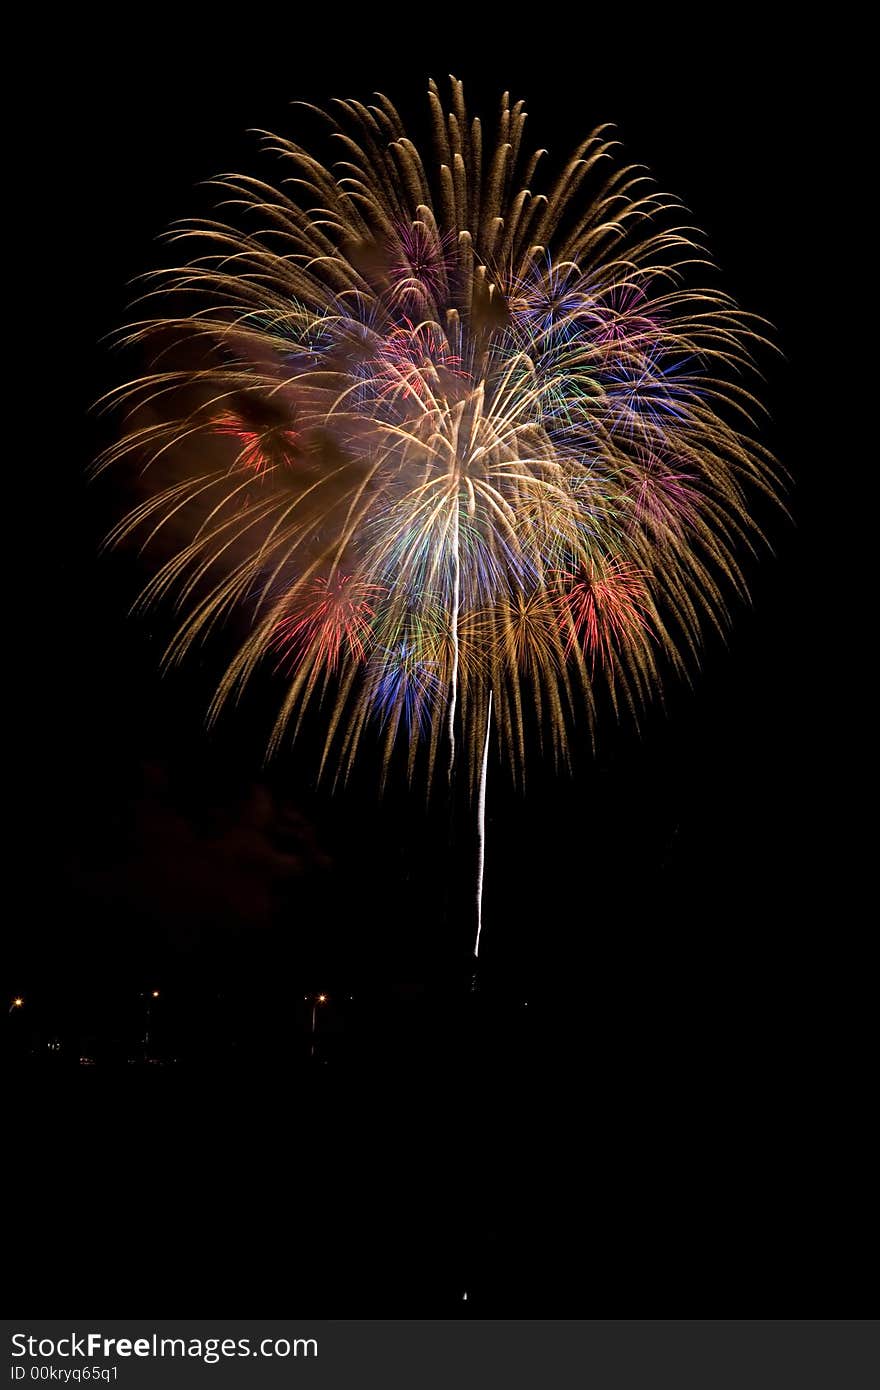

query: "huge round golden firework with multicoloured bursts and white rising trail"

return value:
[101, 81, 779, 956]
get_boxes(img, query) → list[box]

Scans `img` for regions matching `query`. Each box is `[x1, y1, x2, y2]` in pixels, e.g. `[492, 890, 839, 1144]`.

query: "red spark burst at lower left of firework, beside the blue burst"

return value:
[272, 570, 382, 673]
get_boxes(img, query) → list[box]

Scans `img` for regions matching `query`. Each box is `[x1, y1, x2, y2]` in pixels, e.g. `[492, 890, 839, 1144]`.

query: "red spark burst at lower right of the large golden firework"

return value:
[559, 560, 651, 671]
